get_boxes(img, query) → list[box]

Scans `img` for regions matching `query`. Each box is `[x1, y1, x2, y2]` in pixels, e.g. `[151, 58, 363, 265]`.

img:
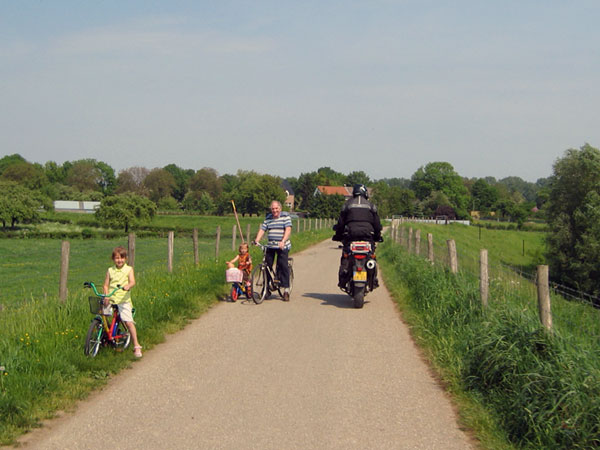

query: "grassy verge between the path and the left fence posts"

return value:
[0, 230, 331, 444]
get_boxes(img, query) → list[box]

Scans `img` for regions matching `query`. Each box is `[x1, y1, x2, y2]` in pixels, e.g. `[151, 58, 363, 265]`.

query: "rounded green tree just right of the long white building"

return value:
[95, 194, 156, 232]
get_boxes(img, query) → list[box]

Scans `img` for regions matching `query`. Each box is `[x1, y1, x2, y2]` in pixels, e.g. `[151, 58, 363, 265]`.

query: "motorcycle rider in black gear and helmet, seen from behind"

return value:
[332, 184, 383, 290]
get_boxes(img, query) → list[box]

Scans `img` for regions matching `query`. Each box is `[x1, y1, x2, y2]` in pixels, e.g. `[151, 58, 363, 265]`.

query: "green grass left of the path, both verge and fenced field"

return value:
[0, 225, 332, 445]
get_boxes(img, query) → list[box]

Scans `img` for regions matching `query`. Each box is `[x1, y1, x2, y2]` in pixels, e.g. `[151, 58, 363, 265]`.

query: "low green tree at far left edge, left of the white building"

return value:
[0, 181, 52, 228]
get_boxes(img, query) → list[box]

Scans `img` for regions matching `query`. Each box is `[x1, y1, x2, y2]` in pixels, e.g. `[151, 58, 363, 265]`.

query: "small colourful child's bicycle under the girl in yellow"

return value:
[83, 281, 135, 357]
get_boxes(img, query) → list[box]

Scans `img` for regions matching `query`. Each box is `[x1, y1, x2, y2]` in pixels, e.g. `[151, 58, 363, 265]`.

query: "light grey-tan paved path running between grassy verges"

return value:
[21, 241, 472, 450]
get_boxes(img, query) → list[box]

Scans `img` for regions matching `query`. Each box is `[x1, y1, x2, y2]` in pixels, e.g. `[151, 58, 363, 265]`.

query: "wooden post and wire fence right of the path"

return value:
[390, 220, 600, 343]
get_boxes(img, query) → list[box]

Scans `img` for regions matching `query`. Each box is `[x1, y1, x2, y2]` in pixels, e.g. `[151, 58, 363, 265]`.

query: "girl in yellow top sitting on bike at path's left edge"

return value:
[103, 247, 142, 358]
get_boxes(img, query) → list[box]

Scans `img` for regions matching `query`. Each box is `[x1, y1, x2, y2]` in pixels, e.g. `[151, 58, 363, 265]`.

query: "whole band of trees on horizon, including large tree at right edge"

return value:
[0, 144, 600, 303]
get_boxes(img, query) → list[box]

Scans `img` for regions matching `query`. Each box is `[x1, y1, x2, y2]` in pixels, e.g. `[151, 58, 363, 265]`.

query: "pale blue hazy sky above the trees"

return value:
[0, 0, 600, 181]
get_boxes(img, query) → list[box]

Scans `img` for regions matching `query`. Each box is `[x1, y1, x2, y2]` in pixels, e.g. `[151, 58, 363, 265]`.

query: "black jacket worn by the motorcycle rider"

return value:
[333, 196, 381, 241]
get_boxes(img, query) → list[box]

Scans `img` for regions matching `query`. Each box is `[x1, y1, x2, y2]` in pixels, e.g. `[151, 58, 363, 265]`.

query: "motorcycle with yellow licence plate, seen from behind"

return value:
[344, 241, 378, 308]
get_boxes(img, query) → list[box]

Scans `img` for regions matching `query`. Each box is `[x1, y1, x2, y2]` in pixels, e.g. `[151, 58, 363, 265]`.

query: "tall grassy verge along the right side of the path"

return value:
[378, 242, 600, 449]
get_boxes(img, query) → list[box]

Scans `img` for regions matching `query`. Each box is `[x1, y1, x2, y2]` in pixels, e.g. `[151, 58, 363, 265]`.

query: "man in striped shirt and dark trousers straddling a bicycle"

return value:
[254, 200, 292, 302]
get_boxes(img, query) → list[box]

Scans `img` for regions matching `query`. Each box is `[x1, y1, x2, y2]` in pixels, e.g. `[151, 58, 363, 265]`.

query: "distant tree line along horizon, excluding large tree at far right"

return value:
[0, 154, 549, 226]
